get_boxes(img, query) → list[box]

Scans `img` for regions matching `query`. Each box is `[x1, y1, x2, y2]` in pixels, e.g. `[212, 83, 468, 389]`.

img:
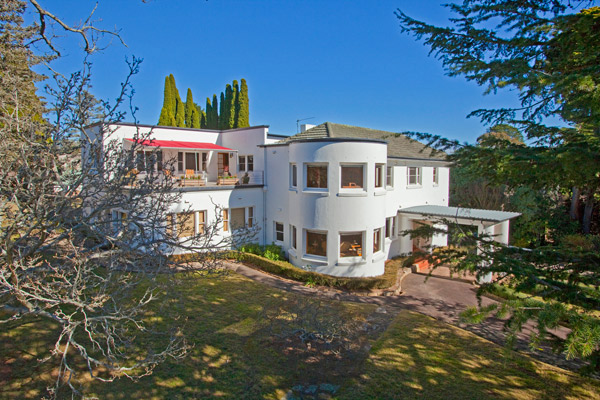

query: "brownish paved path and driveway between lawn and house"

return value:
[226, 262, 583, 370]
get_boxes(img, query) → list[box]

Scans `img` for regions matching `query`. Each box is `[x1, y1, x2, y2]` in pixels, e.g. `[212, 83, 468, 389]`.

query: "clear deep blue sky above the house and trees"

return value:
[42, 0, 516, 142]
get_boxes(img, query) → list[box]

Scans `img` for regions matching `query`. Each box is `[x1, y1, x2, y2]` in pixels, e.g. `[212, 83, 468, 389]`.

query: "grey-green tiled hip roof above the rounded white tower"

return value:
[279, 122, 446, 160]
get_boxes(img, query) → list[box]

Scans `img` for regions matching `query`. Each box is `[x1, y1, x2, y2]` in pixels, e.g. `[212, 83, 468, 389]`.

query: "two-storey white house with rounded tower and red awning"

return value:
[84, 122, 518, 276]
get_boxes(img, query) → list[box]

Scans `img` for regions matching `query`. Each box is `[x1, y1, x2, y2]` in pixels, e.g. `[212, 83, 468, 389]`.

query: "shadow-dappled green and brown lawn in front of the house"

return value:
[0, 274, 600, 399]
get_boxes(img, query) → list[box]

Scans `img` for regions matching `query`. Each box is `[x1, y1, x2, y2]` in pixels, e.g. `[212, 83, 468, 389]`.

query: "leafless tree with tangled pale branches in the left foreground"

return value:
[0, 0, 252, 396]
